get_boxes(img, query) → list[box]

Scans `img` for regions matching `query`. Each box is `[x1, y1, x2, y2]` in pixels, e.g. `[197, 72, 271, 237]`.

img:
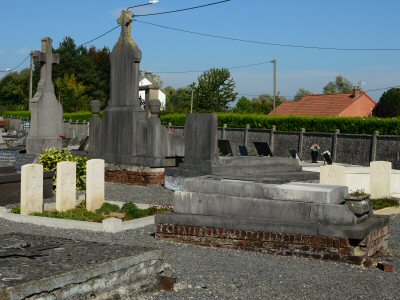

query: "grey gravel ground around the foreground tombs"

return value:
[0, 183, 400, 299]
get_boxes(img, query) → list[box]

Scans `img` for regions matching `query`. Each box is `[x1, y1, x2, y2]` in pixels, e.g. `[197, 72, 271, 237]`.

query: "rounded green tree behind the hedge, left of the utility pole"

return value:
[193, 68, 237, 112]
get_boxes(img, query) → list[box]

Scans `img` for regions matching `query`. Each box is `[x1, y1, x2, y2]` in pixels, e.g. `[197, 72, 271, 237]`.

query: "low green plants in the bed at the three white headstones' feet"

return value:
[11, 201, 170, 223]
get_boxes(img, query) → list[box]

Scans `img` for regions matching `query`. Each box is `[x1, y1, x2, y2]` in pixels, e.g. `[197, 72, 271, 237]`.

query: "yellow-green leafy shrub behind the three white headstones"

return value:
[39, 148, 87, 191]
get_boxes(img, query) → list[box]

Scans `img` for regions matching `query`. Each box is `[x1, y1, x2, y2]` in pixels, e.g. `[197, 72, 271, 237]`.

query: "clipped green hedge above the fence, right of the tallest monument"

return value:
[161, 113, 400, 135]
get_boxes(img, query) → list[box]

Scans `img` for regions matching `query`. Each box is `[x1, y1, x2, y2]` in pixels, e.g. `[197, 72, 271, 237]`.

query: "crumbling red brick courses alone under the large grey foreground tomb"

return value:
[156, 224, 390, 265]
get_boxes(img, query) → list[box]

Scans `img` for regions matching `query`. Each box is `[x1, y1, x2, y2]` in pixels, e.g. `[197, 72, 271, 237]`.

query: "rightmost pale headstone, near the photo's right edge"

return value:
[369, 161, 393, 198]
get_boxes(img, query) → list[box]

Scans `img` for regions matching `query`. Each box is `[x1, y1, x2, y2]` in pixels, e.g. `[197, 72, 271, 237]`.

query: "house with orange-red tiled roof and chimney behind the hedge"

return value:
[269, 88, 376, 117]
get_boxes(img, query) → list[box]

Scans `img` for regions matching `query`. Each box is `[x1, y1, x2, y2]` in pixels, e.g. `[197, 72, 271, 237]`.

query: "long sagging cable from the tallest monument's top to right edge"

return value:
[133, 19, 400, 51]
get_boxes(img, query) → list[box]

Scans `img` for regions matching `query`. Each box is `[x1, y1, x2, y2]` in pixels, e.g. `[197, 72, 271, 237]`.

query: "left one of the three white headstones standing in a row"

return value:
[21, 164, 43, 215]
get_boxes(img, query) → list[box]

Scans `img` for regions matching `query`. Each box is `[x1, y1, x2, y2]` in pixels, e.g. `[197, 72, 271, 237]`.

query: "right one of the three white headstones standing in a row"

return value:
[86, 159, 104, 211]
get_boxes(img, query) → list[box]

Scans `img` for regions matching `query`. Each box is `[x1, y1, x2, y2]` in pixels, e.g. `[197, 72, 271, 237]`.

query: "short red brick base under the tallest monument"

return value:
[105, 164, 165, 186]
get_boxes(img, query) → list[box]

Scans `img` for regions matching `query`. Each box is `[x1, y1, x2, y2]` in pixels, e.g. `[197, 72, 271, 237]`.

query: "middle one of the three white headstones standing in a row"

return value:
[56, 161, 76, 211]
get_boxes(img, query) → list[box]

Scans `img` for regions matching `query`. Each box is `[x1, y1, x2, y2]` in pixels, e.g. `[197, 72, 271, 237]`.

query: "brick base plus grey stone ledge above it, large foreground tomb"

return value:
[156, 213, 390, 265]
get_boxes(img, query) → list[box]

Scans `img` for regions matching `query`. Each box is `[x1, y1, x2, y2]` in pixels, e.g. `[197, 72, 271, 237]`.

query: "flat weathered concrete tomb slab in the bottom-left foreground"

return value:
[0, 233, 164, 299]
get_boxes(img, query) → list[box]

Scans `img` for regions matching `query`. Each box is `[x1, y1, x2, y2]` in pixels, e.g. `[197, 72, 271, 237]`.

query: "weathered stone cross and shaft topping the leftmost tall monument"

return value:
[32, 37, 60, 102]
